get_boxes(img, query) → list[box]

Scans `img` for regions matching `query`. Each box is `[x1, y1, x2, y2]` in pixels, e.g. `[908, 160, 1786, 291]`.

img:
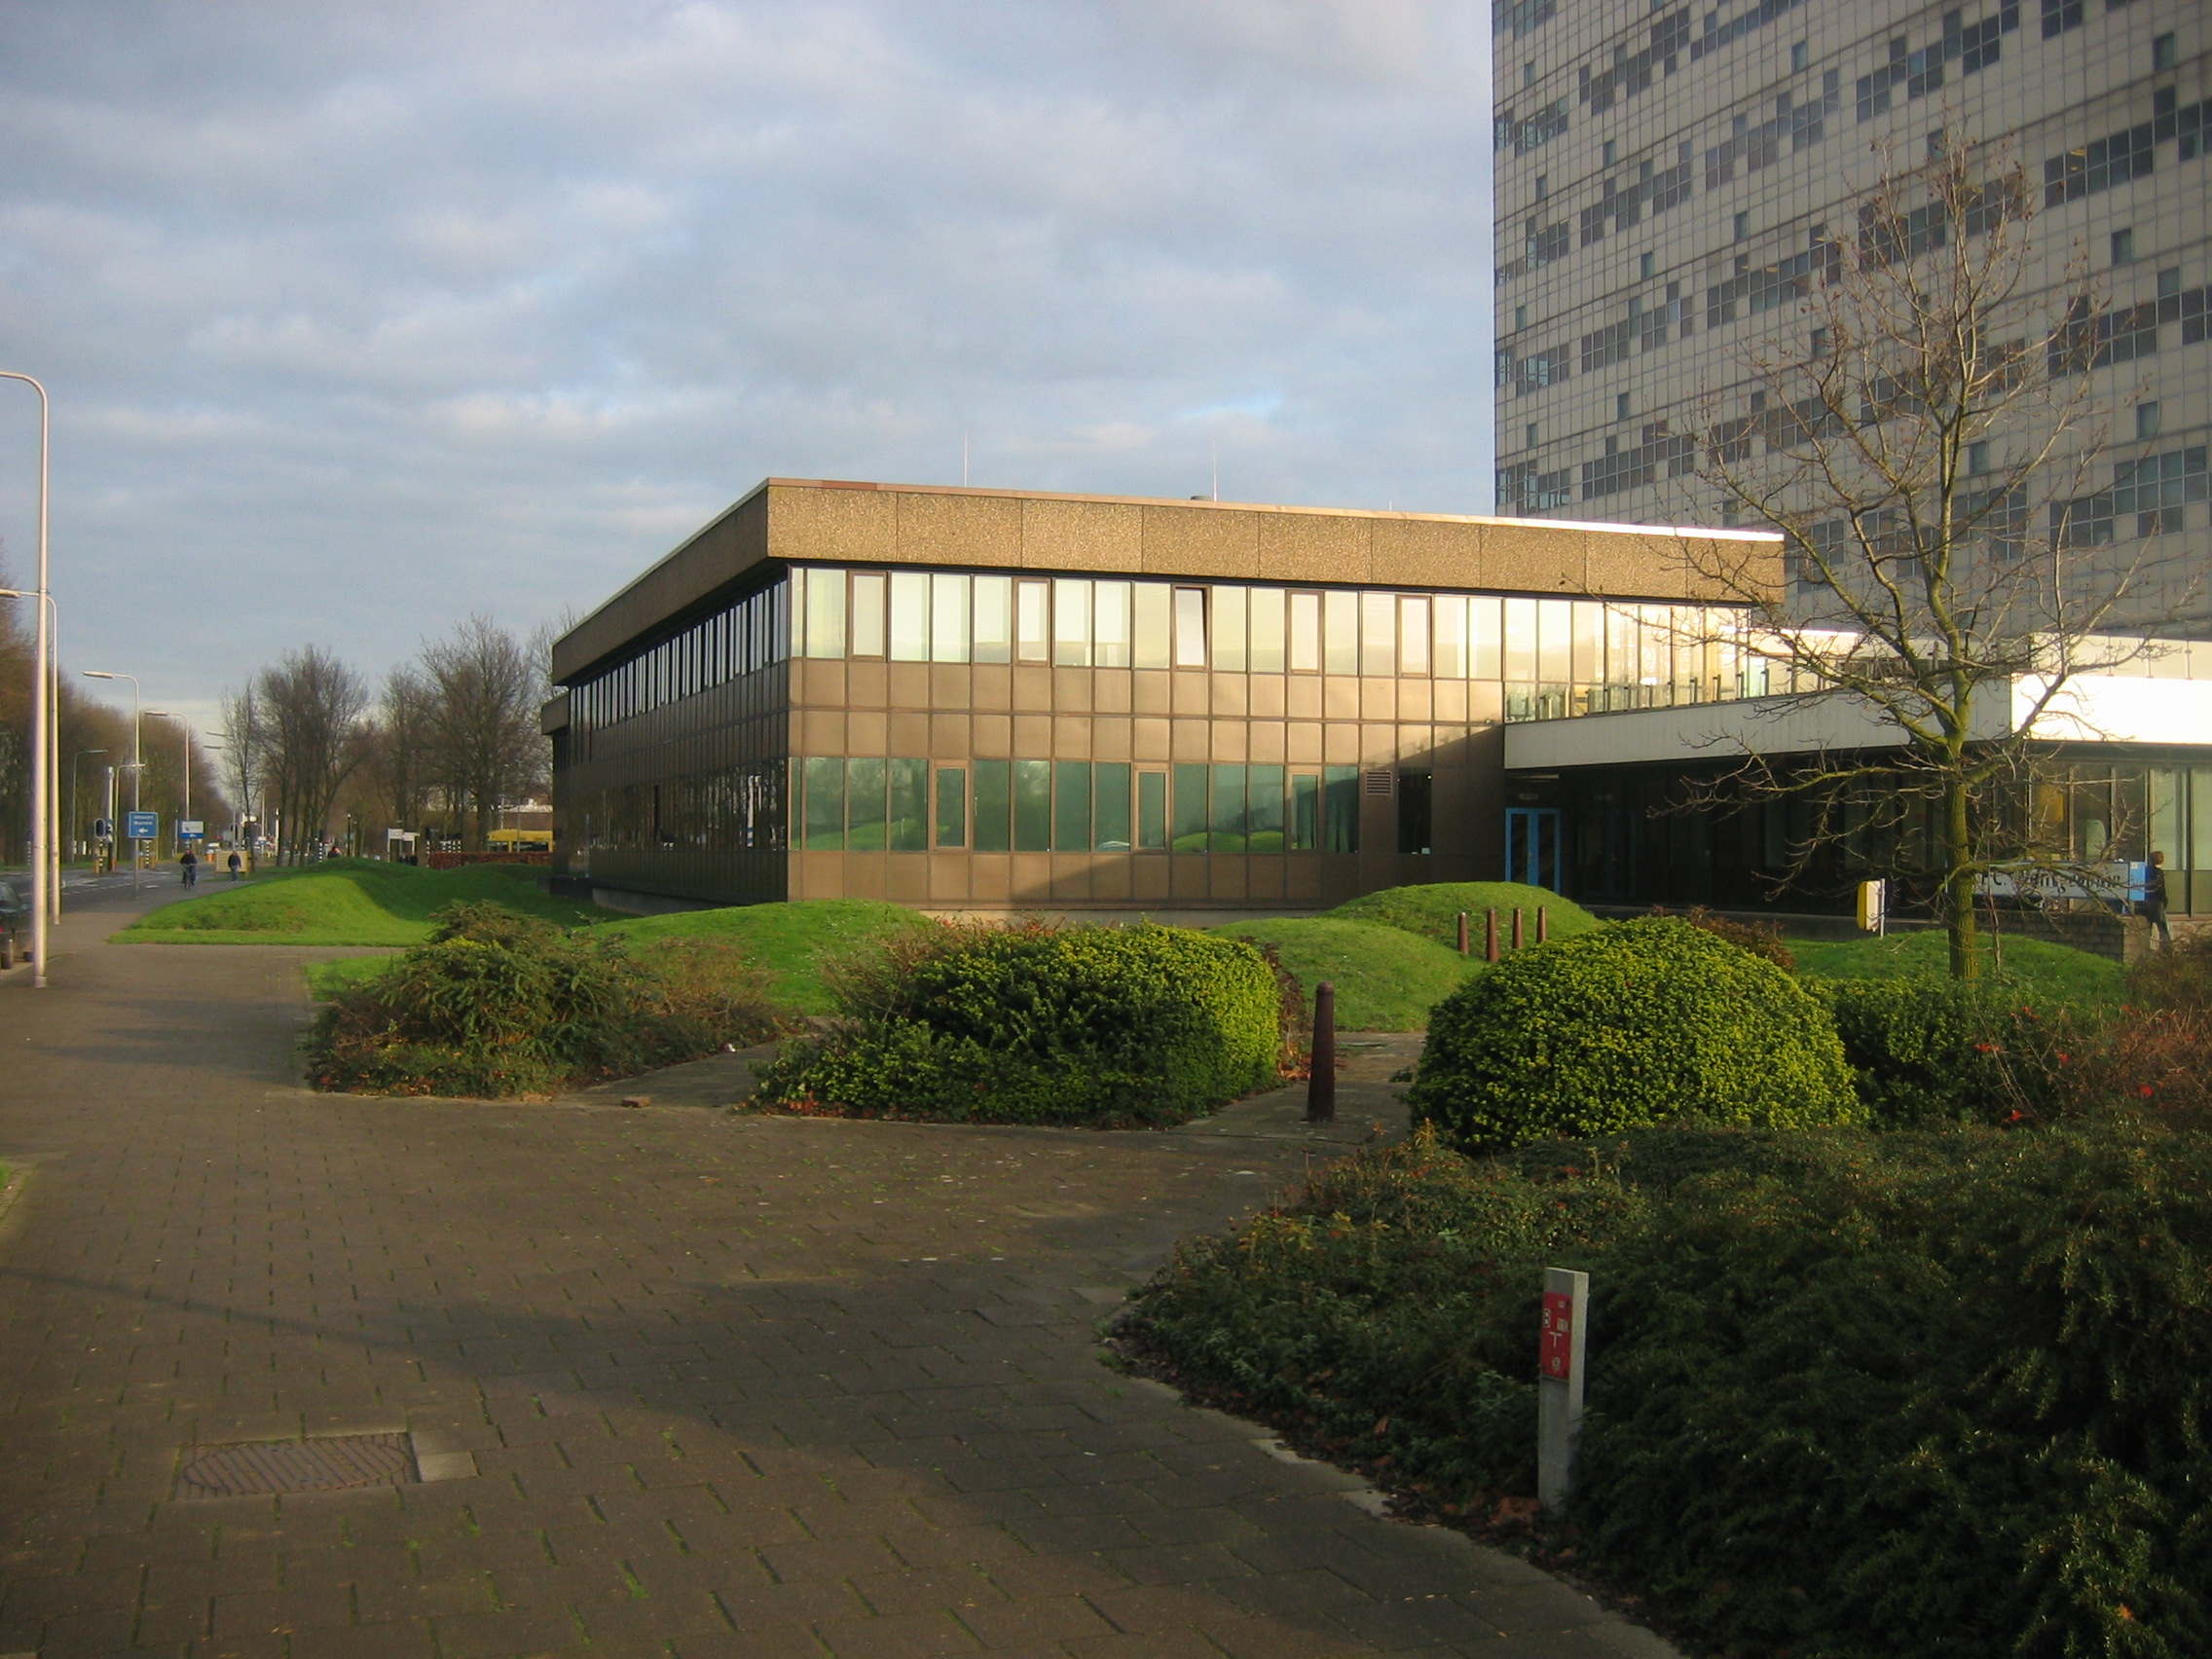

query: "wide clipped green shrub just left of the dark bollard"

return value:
[756, 925, 1283, 1124]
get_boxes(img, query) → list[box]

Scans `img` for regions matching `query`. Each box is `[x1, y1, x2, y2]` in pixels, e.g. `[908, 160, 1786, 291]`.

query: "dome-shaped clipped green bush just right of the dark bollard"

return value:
[1407, 918, 1864, 1150]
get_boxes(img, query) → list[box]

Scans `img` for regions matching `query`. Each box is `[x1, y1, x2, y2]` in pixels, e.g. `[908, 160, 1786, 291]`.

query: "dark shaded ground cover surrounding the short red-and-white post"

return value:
[1120, 1113, 2212, 1659]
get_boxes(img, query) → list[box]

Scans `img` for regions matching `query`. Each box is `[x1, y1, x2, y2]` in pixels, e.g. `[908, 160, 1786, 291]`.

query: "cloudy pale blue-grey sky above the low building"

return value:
[0, 0, 1491, 713]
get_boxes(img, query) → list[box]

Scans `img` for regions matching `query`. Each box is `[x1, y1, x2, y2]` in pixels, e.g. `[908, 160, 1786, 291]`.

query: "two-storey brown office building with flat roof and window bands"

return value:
[546, 478, 1781, 913]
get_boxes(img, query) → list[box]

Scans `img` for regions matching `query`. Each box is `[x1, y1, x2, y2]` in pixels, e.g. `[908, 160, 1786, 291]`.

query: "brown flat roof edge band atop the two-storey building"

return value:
[553, 478, 1783, 685]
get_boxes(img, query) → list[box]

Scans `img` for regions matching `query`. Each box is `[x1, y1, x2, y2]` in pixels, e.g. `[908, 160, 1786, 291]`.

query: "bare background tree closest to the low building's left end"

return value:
[423, 615, 548, 849]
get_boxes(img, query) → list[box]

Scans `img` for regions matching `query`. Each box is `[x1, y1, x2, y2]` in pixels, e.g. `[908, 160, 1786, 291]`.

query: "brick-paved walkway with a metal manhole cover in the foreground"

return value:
[0, 896, 1668, 1659]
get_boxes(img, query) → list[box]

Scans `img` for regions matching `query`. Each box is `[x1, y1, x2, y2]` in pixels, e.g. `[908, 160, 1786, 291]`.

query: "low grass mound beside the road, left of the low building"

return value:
[115, 859, 608, 944]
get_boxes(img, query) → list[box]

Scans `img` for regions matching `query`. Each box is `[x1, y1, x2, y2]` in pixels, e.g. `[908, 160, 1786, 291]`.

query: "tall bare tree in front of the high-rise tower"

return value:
[1697, 148, 2185, 979]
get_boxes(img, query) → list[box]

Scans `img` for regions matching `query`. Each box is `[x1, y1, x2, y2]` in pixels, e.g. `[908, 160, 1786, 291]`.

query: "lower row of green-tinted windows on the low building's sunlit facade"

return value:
[792, 755, 1362, 852]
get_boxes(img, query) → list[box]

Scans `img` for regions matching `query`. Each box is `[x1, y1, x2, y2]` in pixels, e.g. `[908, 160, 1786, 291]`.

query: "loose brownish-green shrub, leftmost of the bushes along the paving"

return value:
[306, 903, 776, 1097]
